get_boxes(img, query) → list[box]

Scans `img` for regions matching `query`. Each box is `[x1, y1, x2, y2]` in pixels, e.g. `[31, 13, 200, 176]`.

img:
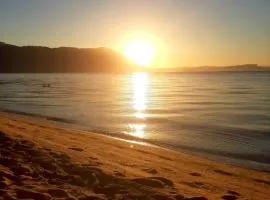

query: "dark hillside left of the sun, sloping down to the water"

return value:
[0, 42, 141, 73]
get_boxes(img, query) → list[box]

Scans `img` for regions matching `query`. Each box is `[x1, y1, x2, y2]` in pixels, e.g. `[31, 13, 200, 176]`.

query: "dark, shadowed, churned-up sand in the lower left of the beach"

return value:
[0, 131, 213, 200]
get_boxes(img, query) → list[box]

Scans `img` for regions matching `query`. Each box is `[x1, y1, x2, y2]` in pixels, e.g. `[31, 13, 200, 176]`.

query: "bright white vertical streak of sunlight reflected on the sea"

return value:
[128, 72, 148, 138]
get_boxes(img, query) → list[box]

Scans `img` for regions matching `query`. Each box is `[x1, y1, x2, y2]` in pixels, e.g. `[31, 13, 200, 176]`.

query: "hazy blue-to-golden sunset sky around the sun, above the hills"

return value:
[0, 0, 270, 67]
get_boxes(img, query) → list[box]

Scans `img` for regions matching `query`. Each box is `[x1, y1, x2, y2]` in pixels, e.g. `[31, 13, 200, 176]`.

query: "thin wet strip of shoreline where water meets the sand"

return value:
[0, 109, 270, 173]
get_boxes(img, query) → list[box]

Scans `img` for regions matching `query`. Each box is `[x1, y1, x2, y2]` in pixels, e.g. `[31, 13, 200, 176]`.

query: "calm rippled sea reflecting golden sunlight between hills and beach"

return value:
[0, 72, 270, 170]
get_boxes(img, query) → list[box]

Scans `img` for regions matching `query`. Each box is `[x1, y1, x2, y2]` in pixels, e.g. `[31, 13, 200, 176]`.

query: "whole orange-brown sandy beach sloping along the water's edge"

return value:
[0, 113, 270, 200]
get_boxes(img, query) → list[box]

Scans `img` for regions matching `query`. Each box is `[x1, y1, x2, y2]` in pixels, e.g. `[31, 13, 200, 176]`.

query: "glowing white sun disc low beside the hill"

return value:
[124, 39, 155, 67]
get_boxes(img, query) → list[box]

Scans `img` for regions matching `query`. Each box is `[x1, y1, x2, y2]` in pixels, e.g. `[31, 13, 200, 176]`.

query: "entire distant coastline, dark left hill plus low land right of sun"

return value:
[0, 42, 270, 73]
